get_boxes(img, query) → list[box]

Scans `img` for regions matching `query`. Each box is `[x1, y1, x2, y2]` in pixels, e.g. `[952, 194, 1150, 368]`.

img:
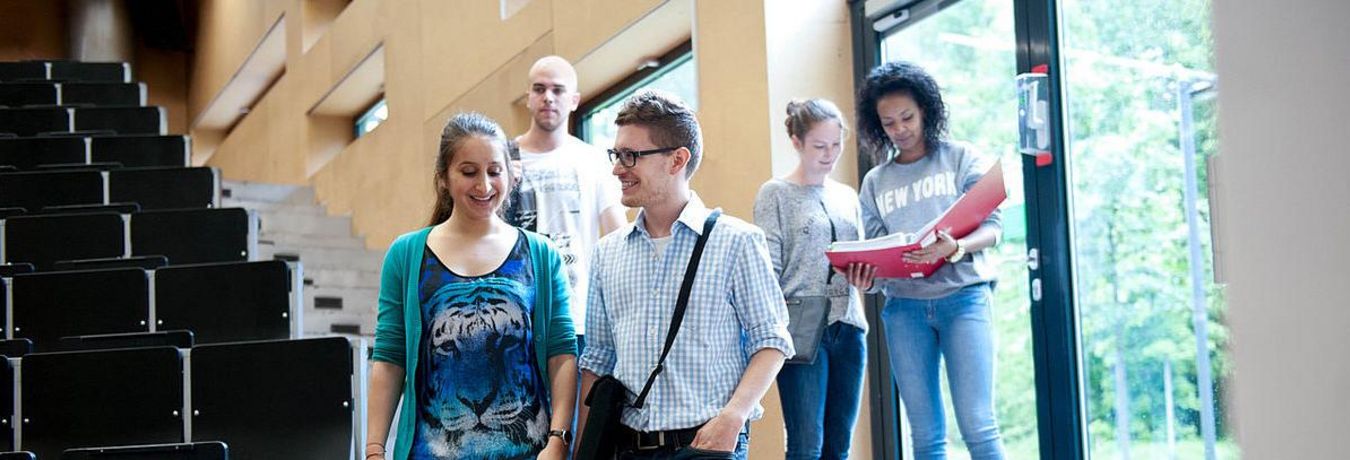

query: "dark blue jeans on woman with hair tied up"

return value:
[778, 322, 867, 460]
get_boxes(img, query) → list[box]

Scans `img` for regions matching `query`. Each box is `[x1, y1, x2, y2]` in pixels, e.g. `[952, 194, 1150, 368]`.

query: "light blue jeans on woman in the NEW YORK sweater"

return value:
[882, 283, 1004, 459]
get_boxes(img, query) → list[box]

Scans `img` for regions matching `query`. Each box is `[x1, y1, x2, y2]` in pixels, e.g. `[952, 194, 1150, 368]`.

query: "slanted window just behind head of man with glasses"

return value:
[574, 42, 698, 148]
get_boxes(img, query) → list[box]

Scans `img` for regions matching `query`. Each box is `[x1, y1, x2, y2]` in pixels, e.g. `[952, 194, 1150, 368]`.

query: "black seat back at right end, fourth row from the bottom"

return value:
[108, 167, 220, 210]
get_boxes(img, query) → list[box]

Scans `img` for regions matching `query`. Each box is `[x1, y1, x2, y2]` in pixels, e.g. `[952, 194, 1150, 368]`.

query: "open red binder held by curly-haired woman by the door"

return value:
[825, 161, 1008, 278]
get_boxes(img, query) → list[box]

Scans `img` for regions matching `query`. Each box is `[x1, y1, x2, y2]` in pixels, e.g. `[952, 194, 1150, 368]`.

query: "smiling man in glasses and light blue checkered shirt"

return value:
[578, 90, 792, 459]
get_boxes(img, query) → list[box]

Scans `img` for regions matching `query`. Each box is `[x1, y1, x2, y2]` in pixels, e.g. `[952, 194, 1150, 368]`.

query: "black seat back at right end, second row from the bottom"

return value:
[154, 260, 300, 344]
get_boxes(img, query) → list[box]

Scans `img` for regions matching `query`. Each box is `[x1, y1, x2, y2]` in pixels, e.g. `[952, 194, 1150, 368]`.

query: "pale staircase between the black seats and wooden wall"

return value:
[220, 181, 383, 339]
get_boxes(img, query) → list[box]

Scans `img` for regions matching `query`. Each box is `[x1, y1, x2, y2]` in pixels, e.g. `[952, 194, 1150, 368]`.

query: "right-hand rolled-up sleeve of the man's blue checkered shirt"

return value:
[732, 231, 795, 357]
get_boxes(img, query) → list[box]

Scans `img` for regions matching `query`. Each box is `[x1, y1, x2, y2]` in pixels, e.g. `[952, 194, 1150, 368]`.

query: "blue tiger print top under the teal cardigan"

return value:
[410, 230, 548, 459]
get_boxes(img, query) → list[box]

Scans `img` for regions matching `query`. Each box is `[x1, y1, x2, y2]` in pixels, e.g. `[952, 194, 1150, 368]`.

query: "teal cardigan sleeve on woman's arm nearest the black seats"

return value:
[370, 237, 408, 367]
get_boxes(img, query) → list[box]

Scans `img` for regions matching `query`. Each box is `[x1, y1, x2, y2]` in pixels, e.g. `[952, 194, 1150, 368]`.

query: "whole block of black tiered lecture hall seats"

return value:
[0, 61, 366, 460]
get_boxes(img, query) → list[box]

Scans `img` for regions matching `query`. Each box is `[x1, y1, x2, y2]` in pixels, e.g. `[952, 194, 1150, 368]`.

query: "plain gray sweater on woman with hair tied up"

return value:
[755, 178, 867, 330]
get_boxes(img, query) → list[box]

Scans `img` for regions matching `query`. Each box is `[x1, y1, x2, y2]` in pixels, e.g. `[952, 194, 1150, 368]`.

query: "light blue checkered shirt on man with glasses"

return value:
[579, 196, 792, 432]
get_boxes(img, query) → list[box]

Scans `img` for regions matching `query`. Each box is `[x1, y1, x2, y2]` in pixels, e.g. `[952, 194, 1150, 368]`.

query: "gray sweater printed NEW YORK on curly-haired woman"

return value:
[859, 142, 1003, 299]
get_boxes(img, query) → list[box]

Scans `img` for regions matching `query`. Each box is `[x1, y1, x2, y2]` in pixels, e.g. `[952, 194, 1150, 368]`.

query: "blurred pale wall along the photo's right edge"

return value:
[1214, 0, 1350, 459]
